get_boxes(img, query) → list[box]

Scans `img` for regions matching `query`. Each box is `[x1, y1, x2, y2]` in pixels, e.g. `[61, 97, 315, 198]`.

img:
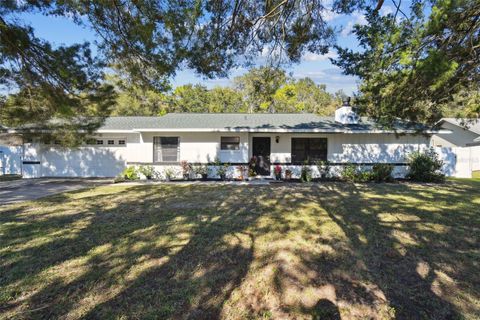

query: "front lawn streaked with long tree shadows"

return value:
[0, 180, 480, 319]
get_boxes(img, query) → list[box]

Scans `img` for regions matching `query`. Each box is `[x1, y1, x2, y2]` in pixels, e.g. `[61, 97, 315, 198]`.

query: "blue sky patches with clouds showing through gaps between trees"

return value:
[13, 4, 393, 95]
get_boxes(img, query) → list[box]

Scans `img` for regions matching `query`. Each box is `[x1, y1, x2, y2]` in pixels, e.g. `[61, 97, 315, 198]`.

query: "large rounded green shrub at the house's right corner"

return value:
[407, 148, 445, 182]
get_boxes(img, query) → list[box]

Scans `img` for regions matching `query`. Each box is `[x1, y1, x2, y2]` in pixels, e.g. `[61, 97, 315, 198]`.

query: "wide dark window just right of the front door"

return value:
[292, 138, 328, 163]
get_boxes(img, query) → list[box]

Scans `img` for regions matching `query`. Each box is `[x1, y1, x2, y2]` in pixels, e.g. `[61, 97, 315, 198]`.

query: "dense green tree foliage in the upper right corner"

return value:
[334, 0, 480, 124]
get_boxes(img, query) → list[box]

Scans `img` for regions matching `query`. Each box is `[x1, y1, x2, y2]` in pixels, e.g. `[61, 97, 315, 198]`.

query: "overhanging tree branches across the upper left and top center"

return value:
[0, 0, 334, 139]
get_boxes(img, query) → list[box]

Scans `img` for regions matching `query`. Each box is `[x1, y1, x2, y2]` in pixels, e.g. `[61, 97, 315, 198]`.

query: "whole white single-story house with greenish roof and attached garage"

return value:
[1, 105, 446, 177]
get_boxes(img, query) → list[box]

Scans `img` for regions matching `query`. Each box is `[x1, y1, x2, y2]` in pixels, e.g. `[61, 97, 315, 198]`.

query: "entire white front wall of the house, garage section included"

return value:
[9, 132, 429, 177]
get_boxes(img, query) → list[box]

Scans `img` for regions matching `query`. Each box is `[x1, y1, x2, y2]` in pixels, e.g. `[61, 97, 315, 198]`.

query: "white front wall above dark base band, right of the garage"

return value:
[126, 132, 429, 164]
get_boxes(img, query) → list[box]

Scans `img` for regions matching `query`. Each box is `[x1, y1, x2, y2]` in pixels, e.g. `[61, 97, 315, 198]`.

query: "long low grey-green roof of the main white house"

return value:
[99, 113, 432, 132]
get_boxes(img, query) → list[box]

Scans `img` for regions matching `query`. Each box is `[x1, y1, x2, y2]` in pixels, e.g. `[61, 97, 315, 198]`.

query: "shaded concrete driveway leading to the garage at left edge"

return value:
[0, 178, 112, 205]
